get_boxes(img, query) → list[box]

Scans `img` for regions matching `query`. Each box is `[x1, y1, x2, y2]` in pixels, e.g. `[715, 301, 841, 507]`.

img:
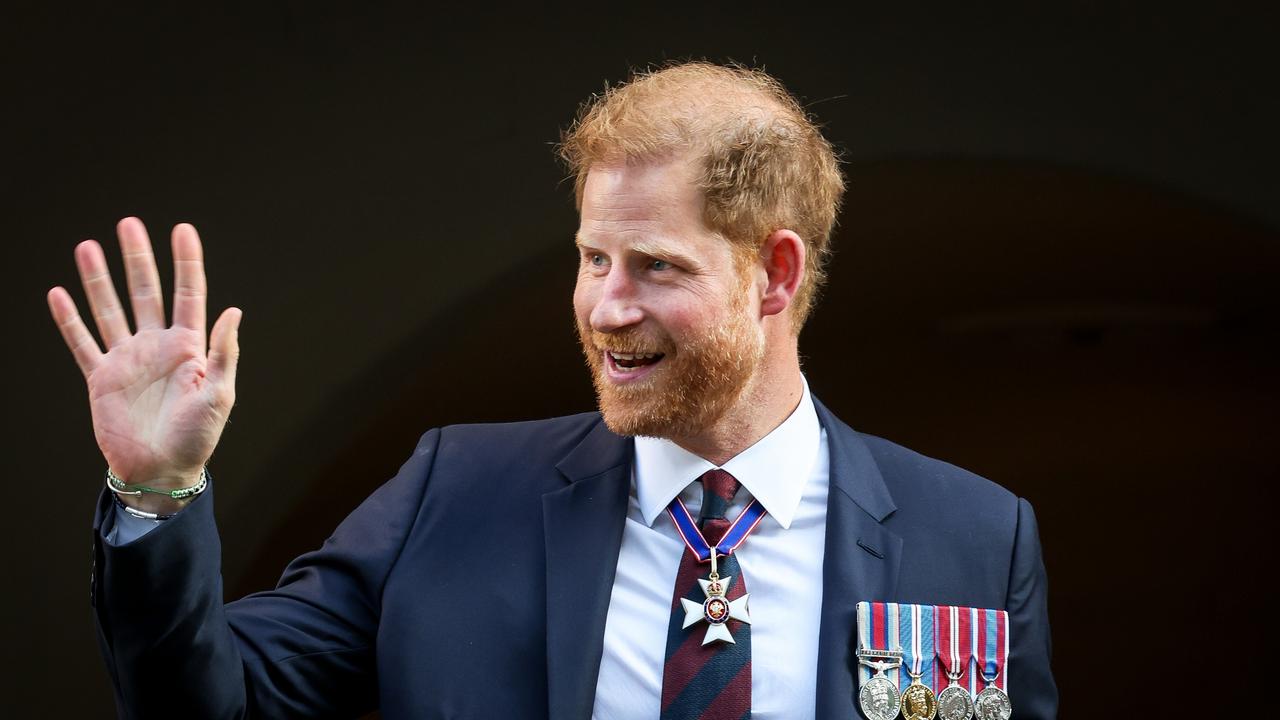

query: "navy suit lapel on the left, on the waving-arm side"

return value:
[543, 421, 635, 720]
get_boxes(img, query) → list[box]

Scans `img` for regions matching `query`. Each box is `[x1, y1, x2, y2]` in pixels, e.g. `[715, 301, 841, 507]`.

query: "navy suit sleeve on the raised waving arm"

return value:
[91, 430, 439, 720]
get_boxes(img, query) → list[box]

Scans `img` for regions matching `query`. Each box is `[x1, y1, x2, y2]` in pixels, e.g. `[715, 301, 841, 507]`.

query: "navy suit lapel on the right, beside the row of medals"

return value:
[814, 400, 902, 720]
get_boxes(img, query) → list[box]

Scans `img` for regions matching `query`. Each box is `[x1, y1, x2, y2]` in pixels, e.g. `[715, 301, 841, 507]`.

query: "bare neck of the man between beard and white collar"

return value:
[671, 348, 804, 465]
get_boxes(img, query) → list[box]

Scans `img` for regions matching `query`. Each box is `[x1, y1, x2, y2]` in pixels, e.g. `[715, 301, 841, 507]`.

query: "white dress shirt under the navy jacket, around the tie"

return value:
[593, 383, 829, 720]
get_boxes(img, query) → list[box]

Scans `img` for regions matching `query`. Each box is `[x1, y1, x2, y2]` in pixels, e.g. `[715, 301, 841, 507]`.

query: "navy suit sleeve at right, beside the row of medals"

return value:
[1006, 498, 1057, 720]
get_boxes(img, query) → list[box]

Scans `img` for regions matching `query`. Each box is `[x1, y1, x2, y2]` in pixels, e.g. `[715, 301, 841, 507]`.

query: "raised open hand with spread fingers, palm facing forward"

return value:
[49, 218, 241, 487]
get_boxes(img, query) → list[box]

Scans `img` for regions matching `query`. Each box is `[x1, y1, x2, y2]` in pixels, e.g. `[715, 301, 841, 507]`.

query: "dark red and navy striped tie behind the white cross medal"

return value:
[662, 469, 751, 720]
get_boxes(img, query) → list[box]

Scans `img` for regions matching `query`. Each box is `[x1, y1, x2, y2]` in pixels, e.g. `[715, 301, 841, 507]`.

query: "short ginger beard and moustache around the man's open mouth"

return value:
[577, 292, 764, 439]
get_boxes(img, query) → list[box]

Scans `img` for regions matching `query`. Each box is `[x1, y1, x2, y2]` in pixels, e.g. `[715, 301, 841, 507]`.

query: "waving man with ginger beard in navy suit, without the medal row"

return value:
[49, 63, 1056, 719]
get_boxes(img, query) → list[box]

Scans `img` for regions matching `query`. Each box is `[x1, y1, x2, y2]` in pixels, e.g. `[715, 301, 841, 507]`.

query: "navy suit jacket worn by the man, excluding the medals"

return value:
[91, 404, 1057, 720]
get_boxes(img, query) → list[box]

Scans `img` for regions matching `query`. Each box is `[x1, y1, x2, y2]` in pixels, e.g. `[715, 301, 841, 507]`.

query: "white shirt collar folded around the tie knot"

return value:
[635, 377, 822, 528]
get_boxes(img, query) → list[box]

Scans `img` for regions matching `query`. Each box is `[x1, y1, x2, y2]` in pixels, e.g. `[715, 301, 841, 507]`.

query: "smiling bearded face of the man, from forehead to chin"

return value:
[573, 152, 764, 438]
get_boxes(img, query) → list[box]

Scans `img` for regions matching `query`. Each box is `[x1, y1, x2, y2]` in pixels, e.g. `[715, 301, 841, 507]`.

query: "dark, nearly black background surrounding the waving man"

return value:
[0, 0, 1280, 717]
